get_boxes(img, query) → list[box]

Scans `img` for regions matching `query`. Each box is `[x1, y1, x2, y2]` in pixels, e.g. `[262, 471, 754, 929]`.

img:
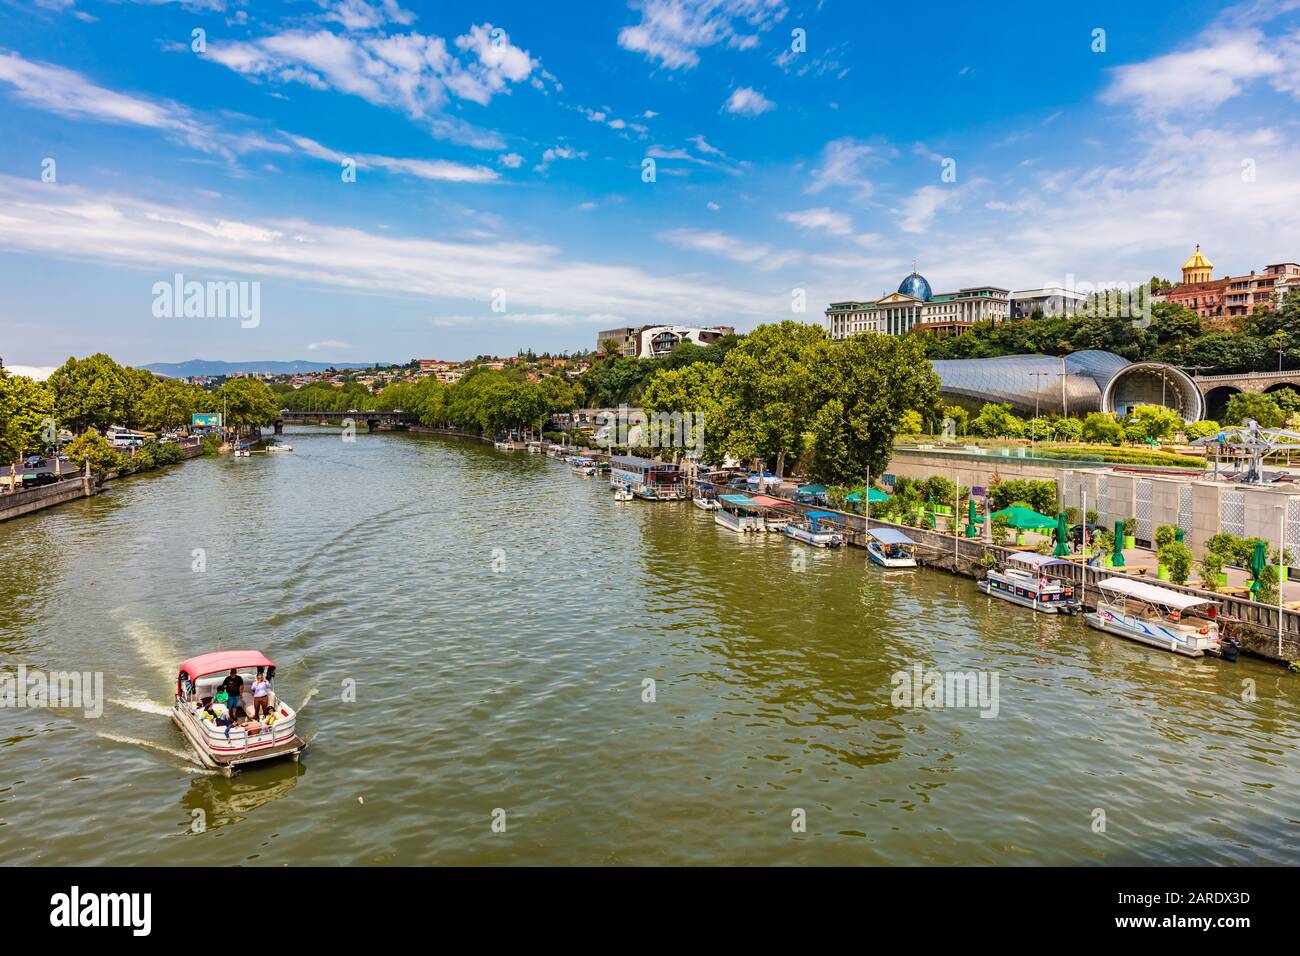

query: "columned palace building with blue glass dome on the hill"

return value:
[826, 265, 1010, 338]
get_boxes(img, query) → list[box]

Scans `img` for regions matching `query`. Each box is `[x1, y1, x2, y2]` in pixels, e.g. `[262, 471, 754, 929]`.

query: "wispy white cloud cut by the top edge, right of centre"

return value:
[619, 0, 788, 70]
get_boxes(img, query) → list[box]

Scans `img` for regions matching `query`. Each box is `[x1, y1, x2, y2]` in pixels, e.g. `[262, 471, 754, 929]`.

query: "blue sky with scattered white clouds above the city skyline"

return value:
[0, 0, 1300, 367]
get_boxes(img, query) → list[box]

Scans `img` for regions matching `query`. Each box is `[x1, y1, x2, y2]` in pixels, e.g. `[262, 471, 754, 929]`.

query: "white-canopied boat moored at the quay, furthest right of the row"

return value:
[1084, 575, 1242, 661]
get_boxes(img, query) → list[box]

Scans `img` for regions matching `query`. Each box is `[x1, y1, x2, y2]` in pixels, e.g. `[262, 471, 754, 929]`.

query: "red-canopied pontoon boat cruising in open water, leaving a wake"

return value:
[172, 650, 307, 777]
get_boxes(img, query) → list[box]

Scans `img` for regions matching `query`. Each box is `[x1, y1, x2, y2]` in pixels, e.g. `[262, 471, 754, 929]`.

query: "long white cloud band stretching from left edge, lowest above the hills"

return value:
[0, 176, 774, 321]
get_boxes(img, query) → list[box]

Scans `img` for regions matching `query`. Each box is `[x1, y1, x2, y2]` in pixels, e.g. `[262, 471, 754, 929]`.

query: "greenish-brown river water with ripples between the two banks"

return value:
[0, 429, 1300, 865]
